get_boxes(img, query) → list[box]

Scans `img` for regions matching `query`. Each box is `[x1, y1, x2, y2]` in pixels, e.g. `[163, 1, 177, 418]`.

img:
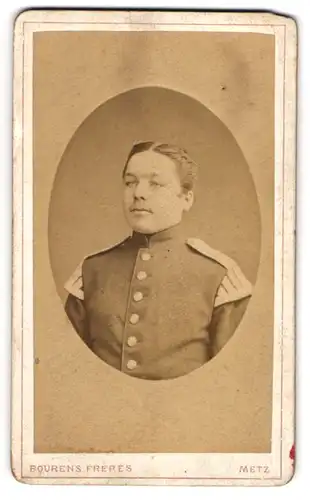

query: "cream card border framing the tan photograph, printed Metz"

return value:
[12, 11, 297, 485]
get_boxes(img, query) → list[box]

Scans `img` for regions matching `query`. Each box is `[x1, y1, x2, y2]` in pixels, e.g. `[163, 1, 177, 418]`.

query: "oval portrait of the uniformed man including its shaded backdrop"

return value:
[49, 87, 261, 380]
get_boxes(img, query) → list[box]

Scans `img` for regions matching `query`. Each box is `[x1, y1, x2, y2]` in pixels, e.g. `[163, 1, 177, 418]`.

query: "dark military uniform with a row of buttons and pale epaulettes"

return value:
[65, 226, 251, 380]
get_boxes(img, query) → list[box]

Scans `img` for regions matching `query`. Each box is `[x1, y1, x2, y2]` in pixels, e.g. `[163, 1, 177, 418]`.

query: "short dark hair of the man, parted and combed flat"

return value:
[122, 141, 198, 191]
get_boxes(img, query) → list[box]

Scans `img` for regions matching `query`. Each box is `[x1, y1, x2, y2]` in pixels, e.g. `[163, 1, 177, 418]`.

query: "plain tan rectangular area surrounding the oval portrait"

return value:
[34, 33, 274, 452]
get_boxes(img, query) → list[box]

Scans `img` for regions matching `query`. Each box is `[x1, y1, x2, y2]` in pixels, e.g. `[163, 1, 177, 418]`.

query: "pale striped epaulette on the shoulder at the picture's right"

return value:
[186, 238, 252, 307]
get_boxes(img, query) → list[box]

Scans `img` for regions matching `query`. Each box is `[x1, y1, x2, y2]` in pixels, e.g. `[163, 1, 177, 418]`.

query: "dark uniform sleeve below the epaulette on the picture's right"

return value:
[209, 297, 250, 357]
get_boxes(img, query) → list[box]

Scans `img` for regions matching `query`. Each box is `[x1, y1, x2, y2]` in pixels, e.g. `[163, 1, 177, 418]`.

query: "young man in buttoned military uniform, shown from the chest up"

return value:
[65, 142, 252, 380]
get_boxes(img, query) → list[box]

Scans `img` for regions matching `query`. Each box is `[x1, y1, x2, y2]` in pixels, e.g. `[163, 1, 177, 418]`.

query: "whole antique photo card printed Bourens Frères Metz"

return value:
[12, 9, 297, 486]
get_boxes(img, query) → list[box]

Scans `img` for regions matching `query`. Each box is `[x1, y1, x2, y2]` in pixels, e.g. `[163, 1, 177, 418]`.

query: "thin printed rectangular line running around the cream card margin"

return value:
[21, 21, 286, 481]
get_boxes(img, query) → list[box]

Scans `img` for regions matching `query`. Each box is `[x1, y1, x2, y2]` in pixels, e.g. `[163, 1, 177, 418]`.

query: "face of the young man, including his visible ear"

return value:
[123, 151, 193, 234]
